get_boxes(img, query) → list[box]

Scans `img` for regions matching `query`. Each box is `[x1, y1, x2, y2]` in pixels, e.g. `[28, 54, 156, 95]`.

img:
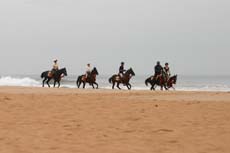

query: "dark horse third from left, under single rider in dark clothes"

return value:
[109, 68, 135, 90]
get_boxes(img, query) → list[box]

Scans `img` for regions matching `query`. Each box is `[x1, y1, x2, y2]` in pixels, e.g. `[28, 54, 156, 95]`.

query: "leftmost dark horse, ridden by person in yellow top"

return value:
[41, 68, 67, 88]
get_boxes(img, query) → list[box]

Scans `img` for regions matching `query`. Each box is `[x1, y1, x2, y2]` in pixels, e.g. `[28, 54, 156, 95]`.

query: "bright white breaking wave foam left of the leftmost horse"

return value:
[0, 76, 41, 87]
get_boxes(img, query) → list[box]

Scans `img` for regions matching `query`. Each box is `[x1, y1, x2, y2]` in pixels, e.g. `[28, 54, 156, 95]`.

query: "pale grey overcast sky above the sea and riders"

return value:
[0, 0, 230, 76]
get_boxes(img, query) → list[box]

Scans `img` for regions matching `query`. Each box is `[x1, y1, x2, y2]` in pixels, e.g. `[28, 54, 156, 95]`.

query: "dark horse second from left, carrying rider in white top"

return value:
[76, 67, 98, 89]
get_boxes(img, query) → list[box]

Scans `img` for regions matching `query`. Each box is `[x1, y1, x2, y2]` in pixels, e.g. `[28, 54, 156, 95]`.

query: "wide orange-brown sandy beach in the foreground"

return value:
[0, 87, 230, 153]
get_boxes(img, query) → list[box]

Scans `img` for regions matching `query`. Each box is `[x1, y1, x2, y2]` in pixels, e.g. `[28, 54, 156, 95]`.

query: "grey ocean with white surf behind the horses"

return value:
[0, 74, 230, 92]
